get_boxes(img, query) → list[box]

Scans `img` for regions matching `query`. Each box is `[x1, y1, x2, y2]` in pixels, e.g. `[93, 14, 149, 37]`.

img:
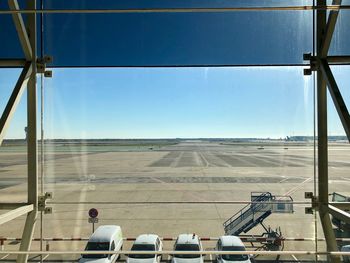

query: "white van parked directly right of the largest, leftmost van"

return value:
[126, 234, 163, 263]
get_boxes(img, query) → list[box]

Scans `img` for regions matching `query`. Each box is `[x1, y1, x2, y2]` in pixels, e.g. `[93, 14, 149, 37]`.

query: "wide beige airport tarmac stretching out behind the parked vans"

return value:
[0, 141, 350, 261]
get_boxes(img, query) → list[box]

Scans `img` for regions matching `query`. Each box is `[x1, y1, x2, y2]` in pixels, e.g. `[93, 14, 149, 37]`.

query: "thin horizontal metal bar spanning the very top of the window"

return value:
[0, 5, 350, 14]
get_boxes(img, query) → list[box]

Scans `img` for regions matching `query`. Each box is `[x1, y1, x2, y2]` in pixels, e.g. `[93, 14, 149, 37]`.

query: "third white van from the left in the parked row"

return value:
[171, 234, 204, 263]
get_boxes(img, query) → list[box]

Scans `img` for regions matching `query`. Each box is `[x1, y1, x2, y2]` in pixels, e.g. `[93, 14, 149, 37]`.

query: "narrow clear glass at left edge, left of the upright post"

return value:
[0, 68, 27, 260]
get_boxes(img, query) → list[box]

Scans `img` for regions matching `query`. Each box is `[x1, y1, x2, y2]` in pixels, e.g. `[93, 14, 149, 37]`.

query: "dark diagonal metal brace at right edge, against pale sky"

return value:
[320, 59, 350, 142]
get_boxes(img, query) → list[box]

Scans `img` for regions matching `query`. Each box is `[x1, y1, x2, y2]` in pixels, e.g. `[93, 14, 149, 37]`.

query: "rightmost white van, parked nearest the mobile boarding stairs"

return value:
[216, 236, 251, 263]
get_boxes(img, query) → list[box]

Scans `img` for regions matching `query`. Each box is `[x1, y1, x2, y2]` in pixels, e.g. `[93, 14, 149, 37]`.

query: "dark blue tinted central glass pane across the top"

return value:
[43, 1, 312, 67]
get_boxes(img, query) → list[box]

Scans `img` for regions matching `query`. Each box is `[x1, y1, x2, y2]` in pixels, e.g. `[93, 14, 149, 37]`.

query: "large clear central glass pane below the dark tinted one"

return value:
[38, 67, 315, 260]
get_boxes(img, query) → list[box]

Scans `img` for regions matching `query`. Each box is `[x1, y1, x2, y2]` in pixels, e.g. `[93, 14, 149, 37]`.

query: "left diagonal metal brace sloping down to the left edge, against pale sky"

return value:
[0, 62, 32, 145]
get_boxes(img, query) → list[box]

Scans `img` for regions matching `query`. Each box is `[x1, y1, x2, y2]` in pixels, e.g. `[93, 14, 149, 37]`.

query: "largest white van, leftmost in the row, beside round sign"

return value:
[79, 225, 123, 263]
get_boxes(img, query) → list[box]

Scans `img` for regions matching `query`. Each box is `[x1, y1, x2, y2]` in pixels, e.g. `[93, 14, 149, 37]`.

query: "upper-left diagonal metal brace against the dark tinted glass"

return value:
[8, 0, 32, 60]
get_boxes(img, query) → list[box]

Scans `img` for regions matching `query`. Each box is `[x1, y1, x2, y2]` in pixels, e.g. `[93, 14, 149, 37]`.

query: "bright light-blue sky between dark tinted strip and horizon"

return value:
[0, 67, 350, 138]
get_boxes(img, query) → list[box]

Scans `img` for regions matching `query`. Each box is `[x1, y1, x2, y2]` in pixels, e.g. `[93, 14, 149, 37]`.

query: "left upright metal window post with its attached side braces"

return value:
[0, 0, 38, 263]
